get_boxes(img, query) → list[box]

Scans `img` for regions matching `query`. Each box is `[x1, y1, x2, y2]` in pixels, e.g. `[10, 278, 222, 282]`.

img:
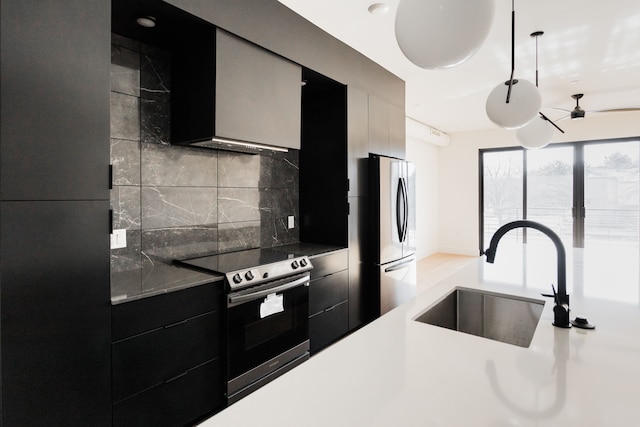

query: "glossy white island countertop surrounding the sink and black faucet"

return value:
[202, 244, 640, 427]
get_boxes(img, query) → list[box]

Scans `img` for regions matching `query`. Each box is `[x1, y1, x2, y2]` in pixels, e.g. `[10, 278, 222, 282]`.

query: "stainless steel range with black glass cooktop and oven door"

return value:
[178, 248, 313, 404]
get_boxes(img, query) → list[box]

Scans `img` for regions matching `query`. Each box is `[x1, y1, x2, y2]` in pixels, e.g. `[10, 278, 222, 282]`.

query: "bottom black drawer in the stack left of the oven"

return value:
[113, 359, 223, 427]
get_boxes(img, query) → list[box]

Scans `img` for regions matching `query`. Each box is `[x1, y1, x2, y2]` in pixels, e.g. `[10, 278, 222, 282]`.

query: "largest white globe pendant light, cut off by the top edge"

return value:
[396, 0, 494, 69]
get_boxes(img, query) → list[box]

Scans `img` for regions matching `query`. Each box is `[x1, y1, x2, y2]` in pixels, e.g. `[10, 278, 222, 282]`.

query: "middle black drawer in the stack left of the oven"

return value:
[112, 311, 222, 402]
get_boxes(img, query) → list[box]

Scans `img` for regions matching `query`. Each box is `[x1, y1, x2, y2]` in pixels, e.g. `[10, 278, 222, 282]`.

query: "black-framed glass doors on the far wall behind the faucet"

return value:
[480, 139, 640, 250]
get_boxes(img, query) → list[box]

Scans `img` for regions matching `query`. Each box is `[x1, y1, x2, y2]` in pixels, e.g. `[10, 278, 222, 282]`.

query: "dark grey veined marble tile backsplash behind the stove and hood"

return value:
[111, 34, 299, 273]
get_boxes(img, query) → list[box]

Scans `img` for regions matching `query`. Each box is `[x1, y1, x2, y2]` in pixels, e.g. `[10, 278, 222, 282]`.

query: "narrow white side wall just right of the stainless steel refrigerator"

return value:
[406, 138, 439, 259]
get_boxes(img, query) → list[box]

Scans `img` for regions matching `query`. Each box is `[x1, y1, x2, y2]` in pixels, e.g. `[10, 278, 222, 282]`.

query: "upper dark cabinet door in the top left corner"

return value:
[0, 0, 111, 200]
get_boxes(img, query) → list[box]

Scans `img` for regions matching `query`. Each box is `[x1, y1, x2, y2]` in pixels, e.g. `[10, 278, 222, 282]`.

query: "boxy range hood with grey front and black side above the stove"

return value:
[171, 25, 302, 154]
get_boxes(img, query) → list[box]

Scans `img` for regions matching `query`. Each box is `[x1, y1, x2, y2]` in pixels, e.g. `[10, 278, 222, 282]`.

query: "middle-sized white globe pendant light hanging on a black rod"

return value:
[486, 80, 542, 129]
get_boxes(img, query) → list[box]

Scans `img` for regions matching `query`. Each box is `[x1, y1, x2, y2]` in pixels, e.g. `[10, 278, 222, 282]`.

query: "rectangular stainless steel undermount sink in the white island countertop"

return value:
[414, 287, 544, 347]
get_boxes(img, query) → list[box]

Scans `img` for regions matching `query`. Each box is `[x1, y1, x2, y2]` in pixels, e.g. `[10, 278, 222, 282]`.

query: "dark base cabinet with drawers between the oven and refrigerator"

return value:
[309, 249, 349, 354]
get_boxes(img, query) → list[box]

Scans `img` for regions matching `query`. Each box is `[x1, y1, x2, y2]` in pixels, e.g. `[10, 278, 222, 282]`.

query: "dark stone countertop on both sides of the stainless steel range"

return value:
[111, 243, 346, 305]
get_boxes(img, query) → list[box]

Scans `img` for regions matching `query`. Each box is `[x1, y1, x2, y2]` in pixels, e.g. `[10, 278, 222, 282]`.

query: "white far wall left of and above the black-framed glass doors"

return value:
[438, 112, 640, 256]
